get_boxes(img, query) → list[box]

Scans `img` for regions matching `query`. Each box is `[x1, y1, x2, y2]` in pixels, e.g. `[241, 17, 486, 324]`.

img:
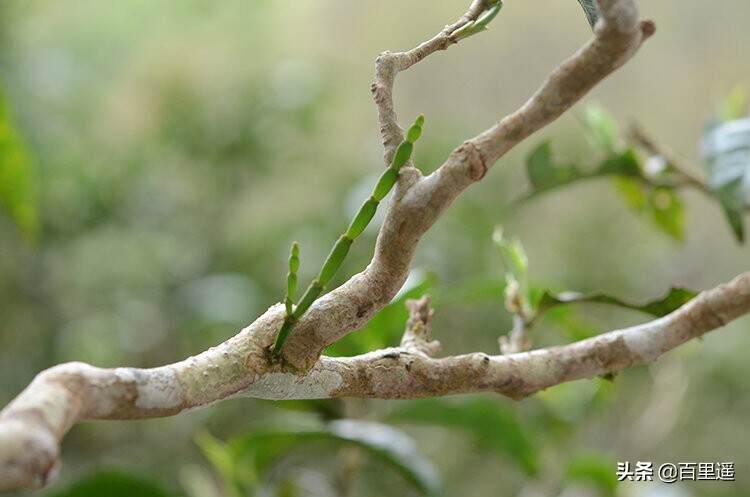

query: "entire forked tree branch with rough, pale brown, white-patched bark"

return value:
[0, 0, 750, 490]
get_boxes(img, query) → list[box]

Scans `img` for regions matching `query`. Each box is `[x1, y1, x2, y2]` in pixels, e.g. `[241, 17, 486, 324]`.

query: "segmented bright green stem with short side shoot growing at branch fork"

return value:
[273, 115, 424, 359]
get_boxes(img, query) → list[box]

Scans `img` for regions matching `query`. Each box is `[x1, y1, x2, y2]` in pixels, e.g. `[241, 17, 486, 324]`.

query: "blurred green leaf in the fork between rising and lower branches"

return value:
[326, 275, 437, 356]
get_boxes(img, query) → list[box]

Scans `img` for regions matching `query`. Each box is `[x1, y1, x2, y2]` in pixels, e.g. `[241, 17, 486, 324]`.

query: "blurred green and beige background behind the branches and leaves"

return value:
[0, 0, 750, 497]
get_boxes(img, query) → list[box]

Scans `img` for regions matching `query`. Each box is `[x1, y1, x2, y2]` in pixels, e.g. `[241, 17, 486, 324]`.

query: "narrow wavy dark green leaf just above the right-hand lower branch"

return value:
[536, 282, 698, 317]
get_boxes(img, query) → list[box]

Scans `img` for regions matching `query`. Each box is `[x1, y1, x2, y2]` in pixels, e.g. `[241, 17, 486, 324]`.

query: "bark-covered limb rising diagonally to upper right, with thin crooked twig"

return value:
[283, 0, 655, 370]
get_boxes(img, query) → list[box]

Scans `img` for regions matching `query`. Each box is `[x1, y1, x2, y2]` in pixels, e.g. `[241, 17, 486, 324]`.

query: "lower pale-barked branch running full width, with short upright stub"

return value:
[0, 272, 750, 490]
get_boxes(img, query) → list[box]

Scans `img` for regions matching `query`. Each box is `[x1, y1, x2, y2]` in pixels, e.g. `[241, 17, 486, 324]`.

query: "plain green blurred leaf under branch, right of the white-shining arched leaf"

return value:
[389, 399, 539, 475]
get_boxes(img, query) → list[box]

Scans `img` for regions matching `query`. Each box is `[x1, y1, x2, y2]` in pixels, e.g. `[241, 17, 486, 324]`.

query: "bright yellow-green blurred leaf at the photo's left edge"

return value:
[0, 85, 39, 240]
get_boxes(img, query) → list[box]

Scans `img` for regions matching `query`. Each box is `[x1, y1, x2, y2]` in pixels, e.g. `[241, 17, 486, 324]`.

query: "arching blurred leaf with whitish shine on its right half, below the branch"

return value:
[230, 420, 441, 495]
